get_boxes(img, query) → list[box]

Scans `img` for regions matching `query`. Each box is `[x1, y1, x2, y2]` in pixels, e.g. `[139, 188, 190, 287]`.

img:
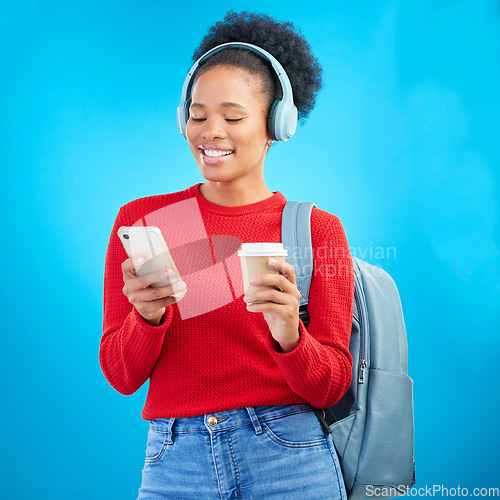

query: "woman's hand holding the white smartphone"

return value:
[122, 258, 186, 326]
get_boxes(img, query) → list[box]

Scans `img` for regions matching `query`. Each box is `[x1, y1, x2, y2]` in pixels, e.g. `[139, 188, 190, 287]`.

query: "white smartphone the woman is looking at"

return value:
[118, 226, 186, 298]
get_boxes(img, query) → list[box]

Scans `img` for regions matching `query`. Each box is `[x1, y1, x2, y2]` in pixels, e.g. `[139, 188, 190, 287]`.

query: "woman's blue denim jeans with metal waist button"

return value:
[138, 403, 347, 500]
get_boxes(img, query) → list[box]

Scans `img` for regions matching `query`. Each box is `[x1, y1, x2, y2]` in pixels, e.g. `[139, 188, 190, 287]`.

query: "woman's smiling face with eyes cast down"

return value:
[186, 66, 270, 186]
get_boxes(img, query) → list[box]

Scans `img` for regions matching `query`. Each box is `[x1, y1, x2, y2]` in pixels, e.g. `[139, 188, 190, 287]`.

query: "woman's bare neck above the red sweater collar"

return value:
[200, 181, 273, 207]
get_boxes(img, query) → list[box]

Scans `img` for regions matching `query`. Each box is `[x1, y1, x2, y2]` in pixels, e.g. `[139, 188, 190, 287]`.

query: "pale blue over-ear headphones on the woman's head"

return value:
[177, 42, 297, 141]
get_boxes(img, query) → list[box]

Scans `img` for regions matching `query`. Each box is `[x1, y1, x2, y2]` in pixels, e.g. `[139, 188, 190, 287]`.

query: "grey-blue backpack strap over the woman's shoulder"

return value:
[281, 201, 316, 306]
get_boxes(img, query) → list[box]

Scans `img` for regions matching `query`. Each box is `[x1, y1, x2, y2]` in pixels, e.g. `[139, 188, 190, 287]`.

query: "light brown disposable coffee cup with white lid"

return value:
[238, 243, 288, 303]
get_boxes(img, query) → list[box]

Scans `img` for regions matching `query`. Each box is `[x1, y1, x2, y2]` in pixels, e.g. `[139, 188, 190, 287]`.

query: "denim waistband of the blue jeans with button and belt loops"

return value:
[150, 403, 320, 443]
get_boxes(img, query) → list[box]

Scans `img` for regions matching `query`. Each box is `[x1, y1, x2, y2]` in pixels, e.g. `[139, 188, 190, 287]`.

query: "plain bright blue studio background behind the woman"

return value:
[0, 0, 500, 500]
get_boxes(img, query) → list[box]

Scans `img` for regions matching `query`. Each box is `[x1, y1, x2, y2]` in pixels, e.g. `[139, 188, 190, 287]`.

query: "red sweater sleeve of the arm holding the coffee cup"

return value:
[268, 208, 354, 408]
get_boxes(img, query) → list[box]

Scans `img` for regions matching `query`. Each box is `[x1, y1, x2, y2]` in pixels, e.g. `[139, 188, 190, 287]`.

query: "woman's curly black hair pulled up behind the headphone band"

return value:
[193, 11, 322, 122]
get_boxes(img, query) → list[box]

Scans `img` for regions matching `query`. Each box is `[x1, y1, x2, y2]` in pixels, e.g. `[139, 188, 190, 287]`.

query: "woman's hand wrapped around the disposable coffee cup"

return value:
[243, 258, 300, 352]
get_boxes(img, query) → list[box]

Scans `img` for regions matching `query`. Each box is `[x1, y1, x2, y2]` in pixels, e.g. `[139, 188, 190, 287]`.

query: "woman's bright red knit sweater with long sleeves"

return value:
[99, 184, 354, 420]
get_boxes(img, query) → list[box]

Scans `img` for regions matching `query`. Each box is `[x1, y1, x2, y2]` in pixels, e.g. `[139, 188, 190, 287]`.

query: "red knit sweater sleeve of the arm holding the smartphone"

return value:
[99, 206, 173, 395]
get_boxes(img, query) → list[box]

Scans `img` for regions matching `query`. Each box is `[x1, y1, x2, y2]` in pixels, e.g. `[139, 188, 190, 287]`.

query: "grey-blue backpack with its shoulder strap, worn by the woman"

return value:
[281, 201, 415, 500]
